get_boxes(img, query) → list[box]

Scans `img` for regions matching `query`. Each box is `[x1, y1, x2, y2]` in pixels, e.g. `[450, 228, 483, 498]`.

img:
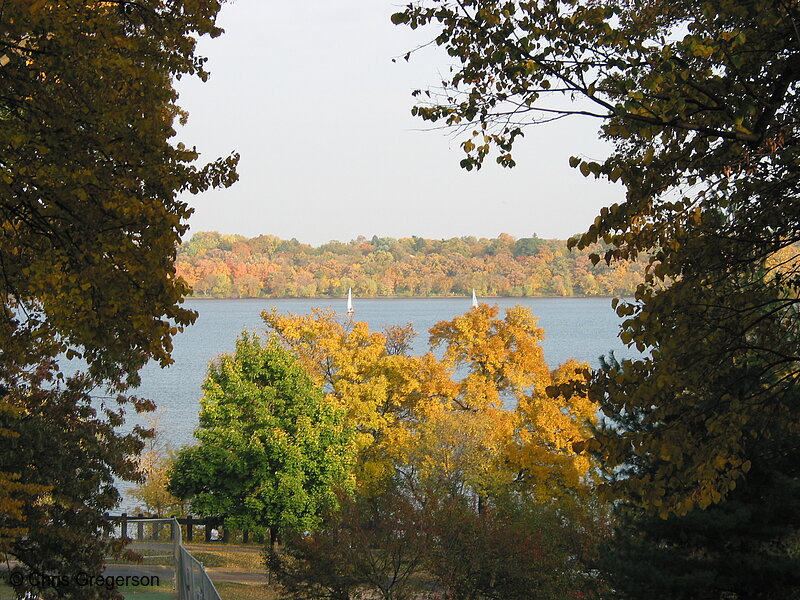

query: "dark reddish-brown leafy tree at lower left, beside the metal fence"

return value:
[0, 364, 148, 598]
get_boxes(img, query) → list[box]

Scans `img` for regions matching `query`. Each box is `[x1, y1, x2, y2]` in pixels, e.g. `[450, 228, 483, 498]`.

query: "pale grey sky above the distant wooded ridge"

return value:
[178, 0, 623, 245]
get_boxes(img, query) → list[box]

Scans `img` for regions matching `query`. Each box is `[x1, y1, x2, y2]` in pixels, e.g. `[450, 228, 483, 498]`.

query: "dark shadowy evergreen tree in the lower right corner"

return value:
[596, 354, 800, 600]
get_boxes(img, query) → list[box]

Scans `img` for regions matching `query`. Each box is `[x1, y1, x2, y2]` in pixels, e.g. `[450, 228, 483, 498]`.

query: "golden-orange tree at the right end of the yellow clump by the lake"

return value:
[431, 304, 597, 498]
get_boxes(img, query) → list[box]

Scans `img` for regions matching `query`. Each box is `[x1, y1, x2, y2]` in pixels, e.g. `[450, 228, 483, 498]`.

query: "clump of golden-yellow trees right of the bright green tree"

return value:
[262, 304, 596, 499]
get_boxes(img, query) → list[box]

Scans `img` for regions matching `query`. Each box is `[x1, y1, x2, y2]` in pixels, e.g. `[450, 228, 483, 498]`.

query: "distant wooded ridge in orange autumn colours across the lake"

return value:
[176, 232, 644, 298]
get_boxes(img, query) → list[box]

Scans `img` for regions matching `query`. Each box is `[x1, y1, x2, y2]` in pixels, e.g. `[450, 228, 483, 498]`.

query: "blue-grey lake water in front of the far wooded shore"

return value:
[131, 298, 635, 447]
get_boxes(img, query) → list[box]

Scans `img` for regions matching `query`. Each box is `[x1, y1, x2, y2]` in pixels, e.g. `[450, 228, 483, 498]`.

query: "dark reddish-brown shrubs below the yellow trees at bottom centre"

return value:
[267, 480, 602, 600]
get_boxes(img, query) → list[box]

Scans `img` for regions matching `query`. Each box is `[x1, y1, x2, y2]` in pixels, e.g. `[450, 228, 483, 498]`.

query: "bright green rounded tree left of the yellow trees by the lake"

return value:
[169, 333, 353, 533]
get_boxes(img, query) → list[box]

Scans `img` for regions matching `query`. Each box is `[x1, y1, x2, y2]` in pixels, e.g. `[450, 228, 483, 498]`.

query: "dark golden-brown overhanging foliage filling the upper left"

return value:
[0, 0, 238, 381]
